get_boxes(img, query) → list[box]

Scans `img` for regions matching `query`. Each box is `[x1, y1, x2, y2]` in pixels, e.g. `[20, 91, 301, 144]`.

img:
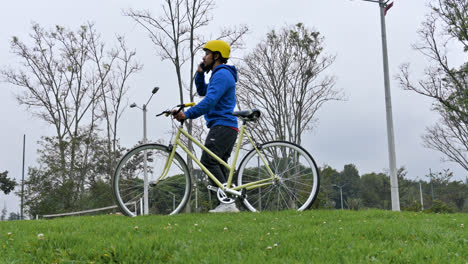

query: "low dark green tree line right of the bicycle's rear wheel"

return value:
[313, 164, 468, 212]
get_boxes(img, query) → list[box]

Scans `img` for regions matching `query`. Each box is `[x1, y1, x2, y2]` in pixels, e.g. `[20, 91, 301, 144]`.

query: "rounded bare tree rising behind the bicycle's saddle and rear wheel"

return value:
[237, 23, 342, 144]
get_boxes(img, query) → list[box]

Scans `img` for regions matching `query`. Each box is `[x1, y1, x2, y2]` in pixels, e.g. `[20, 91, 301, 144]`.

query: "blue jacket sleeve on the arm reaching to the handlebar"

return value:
[185, 70, 229, 119]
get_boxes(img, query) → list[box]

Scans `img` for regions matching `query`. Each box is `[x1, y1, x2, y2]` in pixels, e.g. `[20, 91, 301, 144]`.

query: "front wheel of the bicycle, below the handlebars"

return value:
[112, 144, 191, 216]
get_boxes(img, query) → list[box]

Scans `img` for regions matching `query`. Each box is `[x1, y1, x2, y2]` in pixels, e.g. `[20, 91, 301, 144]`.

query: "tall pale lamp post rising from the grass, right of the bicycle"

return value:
[362, 0, 400, 211]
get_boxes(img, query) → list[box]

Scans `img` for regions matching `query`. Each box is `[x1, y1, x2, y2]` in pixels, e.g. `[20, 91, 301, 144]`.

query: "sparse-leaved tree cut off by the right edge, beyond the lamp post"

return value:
[396, 0, 468, 171]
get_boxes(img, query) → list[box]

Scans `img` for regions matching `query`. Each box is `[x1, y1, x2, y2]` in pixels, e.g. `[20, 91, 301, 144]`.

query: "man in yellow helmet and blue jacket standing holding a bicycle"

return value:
[174, 40, 239, 213]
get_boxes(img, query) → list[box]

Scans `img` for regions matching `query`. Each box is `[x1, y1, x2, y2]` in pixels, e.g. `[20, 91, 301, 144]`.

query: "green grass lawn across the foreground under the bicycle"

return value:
[0, 210, 468, 264]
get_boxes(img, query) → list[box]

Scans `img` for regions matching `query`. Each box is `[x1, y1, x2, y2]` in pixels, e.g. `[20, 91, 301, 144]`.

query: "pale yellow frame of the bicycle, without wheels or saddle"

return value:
[158, 124, 275, 195]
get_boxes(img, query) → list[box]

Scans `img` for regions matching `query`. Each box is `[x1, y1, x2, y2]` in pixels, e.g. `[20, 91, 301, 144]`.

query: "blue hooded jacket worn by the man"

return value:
[185, 64, 237, 128]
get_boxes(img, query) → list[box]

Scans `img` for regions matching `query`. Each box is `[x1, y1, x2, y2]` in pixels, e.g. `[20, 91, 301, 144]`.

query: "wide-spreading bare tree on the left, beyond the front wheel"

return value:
[1, 23, 139, 212]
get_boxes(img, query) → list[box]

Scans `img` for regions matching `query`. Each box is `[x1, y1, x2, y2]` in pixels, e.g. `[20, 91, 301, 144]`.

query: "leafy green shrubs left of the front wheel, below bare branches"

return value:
[24, 134, 126, 217]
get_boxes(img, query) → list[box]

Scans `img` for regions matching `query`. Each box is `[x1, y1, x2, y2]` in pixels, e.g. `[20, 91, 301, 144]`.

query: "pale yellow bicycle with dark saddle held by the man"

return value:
[113, 103, 319, 216]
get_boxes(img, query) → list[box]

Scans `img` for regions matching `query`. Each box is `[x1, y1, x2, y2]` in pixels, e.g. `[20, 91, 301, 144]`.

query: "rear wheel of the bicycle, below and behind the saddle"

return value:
[238, 141, 319, 212]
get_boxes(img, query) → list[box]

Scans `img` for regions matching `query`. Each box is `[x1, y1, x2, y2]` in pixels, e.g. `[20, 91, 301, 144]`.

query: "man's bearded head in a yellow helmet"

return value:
[203, 40, 231, 70]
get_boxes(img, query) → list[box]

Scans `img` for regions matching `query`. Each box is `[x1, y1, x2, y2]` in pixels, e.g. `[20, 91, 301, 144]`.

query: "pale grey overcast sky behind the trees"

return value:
[0, 0, 466, 212]
